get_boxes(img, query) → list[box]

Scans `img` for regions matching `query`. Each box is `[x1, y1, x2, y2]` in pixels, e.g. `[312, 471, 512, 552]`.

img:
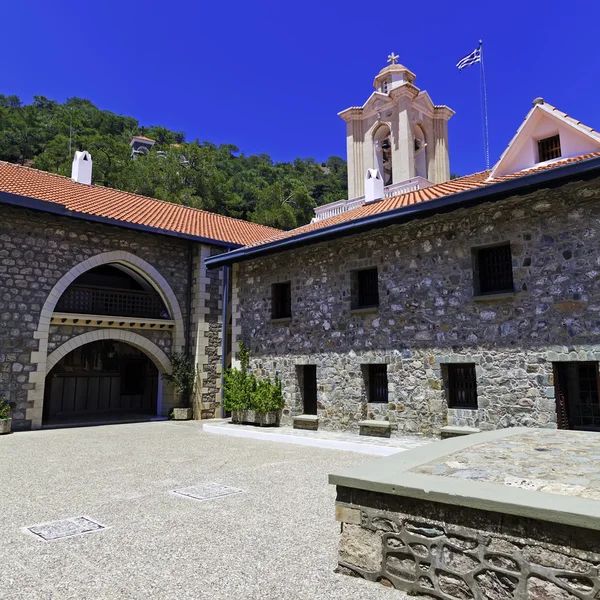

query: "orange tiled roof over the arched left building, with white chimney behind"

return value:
[0, 161, 281, 246]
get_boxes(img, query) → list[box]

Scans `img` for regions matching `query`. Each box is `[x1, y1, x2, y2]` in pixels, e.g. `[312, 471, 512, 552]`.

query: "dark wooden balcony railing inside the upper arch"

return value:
[54, 285, 169, 319]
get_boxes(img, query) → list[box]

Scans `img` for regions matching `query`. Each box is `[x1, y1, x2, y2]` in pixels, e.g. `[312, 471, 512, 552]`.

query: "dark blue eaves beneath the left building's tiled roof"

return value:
[0, 191, 243, 248]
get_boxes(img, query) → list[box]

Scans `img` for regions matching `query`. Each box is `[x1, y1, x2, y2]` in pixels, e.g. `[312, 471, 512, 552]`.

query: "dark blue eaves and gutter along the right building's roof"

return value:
[205, 157, 600, 268]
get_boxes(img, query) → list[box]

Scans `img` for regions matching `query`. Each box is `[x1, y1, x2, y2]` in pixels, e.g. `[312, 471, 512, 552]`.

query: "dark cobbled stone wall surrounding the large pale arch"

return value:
[0, 206, 198, 429]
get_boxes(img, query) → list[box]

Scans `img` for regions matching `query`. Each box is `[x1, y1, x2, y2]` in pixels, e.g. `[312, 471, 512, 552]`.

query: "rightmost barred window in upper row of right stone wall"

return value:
[473, 244, 514, 296]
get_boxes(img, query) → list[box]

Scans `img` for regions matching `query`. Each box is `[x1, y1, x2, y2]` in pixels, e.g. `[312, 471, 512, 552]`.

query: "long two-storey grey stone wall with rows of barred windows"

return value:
[234, 182, 600, 434]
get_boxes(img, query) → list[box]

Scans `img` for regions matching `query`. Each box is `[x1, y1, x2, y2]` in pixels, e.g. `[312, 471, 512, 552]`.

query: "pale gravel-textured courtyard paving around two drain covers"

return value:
[0, 422, 412, 600]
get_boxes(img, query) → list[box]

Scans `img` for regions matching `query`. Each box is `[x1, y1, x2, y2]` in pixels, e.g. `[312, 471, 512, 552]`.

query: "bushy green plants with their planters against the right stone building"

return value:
[223, 342, 284, 426]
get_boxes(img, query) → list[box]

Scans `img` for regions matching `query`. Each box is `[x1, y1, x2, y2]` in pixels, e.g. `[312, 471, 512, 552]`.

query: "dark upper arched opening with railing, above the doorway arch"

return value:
[55, 263, 170, 319]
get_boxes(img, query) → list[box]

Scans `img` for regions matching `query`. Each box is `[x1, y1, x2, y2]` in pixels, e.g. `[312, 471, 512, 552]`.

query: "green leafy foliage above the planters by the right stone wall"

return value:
[223, 342, 284, 413]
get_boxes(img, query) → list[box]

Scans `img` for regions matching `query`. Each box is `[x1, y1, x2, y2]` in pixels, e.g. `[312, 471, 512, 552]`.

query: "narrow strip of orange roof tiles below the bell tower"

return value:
[241, 152, 600, 247]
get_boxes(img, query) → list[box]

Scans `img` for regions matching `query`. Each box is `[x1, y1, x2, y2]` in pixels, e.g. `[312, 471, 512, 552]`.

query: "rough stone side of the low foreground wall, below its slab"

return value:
[336, 487, 600, 600]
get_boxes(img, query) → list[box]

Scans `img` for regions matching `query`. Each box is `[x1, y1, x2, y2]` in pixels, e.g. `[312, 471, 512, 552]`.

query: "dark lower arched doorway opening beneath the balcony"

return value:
[43, 339, 159, 425]
